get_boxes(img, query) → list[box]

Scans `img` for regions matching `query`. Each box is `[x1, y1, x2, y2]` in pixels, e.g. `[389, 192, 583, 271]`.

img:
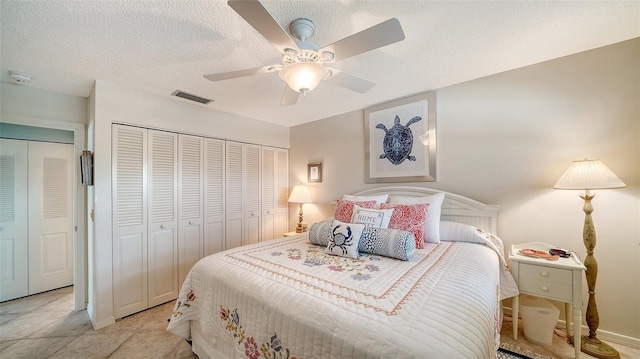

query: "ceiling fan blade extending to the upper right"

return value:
[318, 18, 404, 61]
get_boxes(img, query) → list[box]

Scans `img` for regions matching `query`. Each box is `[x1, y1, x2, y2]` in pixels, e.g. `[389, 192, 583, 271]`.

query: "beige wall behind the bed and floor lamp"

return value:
[290, 39, 640, 345]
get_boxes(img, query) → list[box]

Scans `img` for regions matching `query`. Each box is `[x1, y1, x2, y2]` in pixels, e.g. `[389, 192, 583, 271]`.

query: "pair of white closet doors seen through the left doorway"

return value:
[0, 139, 74, 301]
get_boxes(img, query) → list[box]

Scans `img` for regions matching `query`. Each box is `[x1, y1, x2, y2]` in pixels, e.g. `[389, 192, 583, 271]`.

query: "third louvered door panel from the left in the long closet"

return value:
[178, 135, 204, 285]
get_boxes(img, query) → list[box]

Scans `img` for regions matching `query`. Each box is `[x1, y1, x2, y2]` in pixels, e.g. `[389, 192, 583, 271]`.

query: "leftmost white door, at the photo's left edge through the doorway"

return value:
[0, 139, 29, 301]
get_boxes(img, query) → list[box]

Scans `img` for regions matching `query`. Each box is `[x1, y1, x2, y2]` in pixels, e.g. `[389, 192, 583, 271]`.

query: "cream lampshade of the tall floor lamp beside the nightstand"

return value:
[553, 159, 626, 190]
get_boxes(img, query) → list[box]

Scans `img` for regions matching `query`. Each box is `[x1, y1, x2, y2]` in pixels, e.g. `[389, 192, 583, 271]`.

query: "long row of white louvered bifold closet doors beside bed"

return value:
[112, 124, 288, 318]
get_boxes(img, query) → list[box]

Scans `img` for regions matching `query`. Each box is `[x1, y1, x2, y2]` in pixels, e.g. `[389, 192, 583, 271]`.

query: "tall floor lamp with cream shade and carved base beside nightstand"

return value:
[553, 159, 626, 358]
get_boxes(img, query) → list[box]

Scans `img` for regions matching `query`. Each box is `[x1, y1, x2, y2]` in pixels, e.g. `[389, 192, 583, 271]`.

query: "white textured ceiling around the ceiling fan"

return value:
[0, 0, 640, 126]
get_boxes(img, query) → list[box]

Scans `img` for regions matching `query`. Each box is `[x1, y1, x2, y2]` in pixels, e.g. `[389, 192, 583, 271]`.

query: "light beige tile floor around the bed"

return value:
[0, 287, 640, 359]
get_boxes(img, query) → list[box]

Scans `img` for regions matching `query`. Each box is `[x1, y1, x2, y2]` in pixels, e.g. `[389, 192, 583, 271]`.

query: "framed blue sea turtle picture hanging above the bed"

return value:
[364, 92, 436, 183]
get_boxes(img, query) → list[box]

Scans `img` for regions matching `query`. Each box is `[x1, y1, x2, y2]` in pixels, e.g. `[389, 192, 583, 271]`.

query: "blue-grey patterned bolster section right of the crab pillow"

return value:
[358, 227, 416, 261]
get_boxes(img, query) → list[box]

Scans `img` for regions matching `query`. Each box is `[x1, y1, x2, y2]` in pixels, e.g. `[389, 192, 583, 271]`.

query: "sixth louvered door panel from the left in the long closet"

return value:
[243, 144, 262, 244]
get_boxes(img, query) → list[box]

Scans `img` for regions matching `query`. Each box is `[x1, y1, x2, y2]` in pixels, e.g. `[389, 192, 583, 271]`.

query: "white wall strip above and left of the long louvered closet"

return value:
[88, 81, 289, 329]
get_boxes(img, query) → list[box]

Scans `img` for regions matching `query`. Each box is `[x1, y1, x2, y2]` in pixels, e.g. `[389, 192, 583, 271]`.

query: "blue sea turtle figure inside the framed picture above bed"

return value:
[376, 115, 422, 166]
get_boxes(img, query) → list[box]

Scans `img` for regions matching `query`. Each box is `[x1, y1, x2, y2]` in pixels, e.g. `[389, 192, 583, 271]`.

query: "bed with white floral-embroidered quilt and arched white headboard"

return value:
[167, 186, 518, 359]
